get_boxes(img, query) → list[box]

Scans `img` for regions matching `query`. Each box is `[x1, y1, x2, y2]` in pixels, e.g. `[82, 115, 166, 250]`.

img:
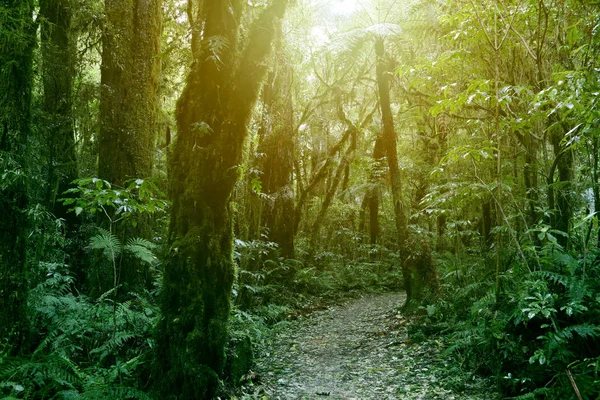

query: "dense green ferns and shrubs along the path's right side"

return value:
[411, 242, 600, 400]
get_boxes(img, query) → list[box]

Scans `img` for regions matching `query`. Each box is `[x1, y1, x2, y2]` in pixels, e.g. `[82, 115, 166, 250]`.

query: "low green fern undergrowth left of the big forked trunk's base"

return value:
[0, 263, 158, 399]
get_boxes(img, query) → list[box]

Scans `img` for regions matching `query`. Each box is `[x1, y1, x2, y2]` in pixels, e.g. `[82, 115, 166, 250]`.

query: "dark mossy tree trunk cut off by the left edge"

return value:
[0, 0, 35, 354]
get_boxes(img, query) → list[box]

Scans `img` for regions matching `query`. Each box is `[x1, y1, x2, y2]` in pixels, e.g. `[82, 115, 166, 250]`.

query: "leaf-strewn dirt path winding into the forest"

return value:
[243, 293, 498, 400]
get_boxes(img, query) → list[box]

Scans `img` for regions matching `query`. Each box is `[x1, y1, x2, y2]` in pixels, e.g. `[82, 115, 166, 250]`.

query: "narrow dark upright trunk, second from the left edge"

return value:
[40, 0, 77, 225]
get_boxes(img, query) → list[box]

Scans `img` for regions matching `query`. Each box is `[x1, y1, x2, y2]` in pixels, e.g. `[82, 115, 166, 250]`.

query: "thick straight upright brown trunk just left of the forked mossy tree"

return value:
[97, 0, 162, 292]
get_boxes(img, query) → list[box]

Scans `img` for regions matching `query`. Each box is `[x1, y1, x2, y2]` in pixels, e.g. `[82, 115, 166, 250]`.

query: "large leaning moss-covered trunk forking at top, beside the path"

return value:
[156, 0, 287, 399]
